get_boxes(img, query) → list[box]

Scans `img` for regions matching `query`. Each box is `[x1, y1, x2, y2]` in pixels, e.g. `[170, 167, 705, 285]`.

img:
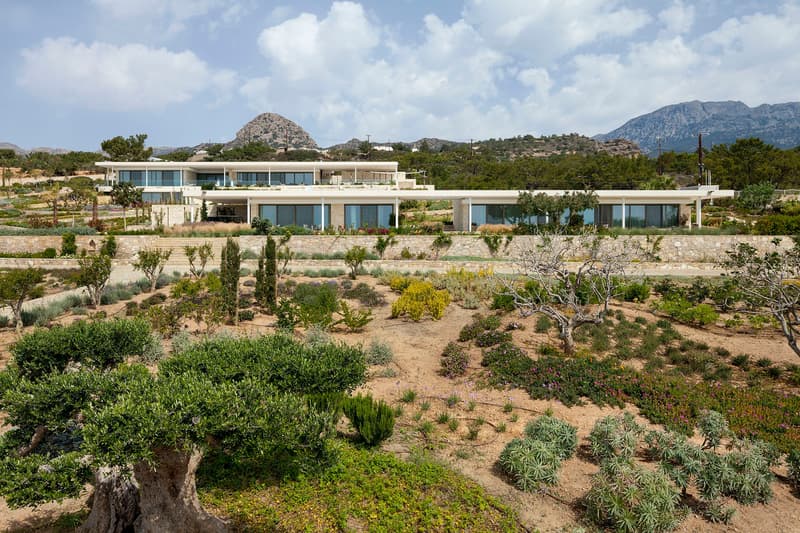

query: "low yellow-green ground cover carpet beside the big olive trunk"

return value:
[198, 445, 522, 532]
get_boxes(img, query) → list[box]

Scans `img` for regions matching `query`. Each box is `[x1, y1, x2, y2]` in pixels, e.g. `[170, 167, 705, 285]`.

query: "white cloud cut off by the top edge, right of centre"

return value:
[463, 0, 651, 64]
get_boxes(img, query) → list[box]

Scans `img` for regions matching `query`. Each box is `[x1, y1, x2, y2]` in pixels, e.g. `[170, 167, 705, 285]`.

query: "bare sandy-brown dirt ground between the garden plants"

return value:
[0, 277, 800, 533]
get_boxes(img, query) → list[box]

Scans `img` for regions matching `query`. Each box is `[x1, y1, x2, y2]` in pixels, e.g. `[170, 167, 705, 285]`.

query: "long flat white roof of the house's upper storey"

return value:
[95, 161, 398, 172]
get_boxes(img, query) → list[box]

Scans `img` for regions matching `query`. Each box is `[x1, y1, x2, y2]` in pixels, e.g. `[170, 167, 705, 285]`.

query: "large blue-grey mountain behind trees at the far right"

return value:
[594, 100, 800, 155]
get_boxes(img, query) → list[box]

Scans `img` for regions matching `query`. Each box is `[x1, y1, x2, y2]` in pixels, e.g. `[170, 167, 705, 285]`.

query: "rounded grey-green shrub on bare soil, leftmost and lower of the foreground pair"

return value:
[499, 439, 561, 492]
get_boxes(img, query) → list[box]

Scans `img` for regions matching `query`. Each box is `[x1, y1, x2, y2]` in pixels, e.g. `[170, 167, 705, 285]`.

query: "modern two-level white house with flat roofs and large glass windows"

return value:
[97, 161, 734, 231]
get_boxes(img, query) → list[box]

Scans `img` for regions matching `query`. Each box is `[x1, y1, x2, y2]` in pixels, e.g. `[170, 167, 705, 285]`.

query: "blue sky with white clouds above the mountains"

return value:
[0, 0, 800, 150]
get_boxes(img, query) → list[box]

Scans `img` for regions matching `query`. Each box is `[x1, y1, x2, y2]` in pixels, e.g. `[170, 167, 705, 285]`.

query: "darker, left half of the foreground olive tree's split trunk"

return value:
[78, 467, 139, 533]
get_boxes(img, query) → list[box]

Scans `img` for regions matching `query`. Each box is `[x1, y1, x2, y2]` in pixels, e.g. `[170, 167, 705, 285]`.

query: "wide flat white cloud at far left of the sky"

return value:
[17, 37, 235, 111]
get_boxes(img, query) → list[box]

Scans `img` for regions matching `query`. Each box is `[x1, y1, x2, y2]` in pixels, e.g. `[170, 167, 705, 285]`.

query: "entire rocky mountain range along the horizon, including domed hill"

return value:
[0, 100, 800, 158]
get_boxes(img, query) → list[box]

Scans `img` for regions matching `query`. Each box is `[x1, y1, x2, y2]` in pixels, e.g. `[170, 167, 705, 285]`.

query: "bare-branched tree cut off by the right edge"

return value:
[721, 238, 800, 355]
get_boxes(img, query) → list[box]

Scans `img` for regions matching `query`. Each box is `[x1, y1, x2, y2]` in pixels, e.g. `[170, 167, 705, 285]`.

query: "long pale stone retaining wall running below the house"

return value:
[0, 235, 793, 263]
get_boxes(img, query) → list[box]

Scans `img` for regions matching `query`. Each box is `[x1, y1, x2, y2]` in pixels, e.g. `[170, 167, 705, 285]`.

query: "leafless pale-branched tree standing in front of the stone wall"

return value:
[501, 230, 641, 353]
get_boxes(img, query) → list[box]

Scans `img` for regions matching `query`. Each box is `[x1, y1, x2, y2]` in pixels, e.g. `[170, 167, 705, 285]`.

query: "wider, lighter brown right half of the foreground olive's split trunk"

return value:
[133, 448, 228, 533]
